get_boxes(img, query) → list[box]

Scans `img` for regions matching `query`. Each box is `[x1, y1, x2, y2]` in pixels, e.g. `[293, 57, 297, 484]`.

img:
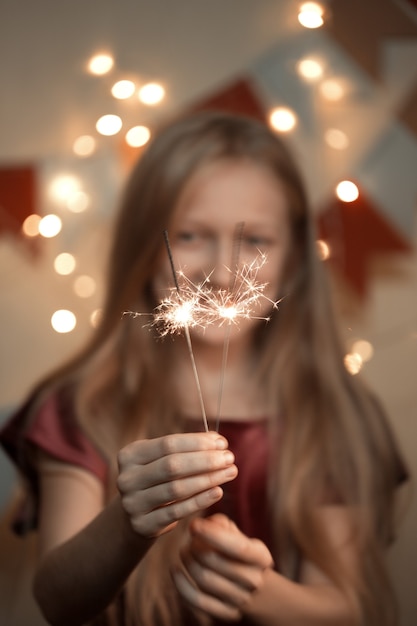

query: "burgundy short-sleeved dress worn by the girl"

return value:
[0, 392, 272, 626]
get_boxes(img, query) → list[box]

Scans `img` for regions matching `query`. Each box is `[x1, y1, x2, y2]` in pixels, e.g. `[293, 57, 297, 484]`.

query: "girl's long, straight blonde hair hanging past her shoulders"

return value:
[26, 112, 402, 626]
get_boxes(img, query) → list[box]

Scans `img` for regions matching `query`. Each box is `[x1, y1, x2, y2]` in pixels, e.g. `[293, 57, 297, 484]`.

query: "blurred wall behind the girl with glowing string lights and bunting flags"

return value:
[0, 0, 417, 626]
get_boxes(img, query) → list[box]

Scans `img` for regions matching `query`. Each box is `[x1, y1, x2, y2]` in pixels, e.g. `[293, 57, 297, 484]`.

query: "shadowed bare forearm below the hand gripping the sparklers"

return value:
[34, 498, 152, 626]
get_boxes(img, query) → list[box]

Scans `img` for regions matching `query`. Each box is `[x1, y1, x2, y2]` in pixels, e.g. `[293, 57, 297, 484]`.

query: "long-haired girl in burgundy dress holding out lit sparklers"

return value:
[2, 112, 404, 626]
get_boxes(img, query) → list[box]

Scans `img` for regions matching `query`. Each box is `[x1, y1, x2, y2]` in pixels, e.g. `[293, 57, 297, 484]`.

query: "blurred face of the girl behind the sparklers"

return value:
[154, 161, 290, 343]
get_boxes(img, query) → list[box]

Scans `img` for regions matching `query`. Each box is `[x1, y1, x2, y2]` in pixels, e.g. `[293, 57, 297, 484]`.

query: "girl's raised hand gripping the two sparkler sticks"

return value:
[117, 432, 237, 537]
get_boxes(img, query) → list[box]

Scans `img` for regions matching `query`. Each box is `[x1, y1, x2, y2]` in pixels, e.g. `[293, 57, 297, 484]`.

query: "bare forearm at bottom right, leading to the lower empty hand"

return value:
[246, 570, 357, 626]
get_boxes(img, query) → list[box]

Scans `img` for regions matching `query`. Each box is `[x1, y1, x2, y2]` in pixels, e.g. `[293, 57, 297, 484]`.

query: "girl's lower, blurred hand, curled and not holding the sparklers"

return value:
[173, 514, 273, 621]
